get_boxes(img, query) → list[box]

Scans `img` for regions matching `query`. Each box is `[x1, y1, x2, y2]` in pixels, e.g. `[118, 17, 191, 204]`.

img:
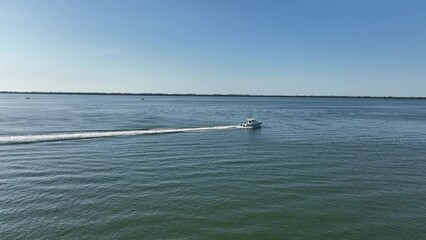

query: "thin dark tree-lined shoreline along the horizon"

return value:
[0, 91, 426, 99]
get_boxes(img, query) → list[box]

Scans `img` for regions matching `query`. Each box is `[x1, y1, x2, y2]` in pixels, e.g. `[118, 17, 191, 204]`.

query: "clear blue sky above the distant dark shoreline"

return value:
[0, 0, 426, 96]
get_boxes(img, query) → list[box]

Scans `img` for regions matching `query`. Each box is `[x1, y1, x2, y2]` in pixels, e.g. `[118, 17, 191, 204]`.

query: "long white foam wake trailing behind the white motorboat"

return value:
[0, 125, 237, 144]
